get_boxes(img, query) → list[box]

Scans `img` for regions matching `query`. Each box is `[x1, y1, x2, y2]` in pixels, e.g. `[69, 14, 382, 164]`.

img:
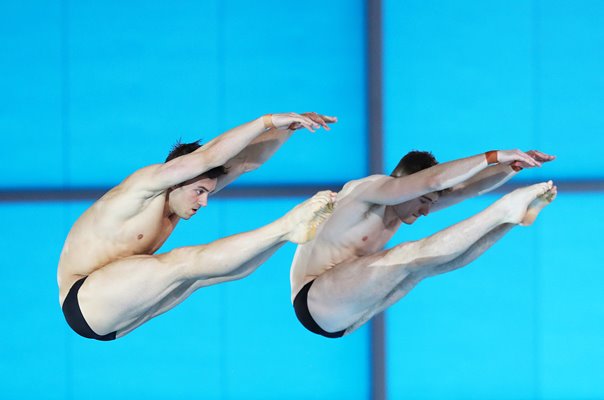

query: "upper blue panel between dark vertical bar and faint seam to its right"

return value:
[383, 0, 538, 171]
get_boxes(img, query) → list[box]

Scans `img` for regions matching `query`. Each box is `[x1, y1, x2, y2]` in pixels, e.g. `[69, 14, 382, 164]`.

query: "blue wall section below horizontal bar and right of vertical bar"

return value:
[387, 194, 604, 399]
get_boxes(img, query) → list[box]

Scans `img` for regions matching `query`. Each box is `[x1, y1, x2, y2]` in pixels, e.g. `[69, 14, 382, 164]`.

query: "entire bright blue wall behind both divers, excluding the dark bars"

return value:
[0, 0, 604, 399]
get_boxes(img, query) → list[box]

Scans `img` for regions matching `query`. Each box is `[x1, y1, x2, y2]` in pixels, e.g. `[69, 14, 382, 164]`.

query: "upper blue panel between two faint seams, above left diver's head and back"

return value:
[68, 0, 219, 186]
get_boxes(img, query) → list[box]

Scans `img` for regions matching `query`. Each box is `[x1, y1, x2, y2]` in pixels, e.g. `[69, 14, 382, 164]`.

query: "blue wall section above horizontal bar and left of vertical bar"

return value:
[0, 0, 367, 187]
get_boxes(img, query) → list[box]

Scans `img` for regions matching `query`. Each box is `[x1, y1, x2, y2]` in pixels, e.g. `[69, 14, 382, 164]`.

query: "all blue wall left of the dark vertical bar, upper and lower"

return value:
[0, 0, 369, 399]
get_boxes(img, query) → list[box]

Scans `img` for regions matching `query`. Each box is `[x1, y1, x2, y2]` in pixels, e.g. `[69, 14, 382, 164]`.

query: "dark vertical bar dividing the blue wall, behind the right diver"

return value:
[366, 0, 386, 400]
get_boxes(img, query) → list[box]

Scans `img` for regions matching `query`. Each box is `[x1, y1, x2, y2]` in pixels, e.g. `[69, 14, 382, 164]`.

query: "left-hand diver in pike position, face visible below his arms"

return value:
[58, 113, 336, 341]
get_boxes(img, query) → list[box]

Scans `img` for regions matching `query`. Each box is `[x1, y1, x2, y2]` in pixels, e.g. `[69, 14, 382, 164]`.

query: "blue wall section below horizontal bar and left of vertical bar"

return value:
[0, 199, 369, 399]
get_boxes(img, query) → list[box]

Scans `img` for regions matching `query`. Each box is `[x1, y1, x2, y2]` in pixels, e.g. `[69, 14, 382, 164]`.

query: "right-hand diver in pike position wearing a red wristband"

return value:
[291, 150, 557, 338]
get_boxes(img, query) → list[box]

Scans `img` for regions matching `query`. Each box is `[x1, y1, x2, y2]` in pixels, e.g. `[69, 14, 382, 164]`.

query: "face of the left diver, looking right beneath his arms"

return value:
[169, 176, 217, 219]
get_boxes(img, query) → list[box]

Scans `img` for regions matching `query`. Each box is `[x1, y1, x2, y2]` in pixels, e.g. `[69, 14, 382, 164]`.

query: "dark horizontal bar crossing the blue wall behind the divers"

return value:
[0, 179, 604, 202]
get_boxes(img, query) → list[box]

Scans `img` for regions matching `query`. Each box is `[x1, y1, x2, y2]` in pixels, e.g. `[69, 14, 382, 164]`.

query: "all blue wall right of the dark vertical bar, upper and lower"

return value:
[384, 0, 604, 399]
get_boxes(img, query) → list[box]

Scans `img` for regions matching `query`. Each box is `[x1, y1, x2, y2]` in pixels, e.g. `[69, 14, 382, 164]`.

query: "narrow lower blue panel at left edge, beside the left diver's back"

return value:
[0, 203, 70, 399]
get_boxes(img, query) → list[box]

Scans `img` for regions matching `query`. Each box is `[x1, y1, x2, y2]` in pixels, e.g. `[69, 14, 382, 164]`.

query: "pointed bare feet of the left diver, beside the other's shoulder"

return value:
[285, 190, 336, 244]
